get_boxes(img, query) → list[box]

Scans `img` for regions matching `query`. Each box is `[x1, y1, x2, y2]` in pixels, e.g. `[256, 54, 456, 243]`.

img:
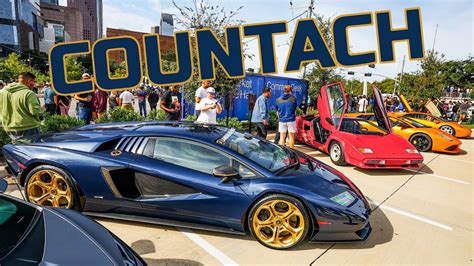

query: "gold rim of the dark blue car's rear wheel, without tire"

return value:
[26, 170, 72, 208]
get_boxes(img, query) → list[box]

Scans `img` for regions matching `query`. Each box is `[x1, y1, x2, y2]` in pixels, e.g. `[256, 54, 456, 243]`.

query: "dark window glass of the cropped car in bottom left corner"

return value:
[0, 196, 39, 260]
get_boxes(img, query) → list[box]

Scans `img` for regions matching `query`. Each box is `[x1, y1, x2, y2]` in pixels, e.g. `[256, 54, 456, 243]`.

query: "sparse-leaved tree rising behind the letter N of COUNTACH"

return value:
[172, 0, 244, 101]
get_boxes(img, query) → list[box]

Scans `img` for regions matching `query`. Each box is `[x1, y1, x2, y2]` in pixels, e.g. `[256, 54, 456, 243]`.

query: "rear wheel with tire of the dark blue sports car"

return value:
[25, 165, 78, 209]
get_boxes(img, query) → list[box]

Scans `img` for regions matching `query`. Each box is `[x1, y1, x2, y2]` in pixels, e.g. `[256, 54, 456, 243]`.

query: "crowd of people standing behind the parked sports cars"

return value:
[0, 73, 471, 147]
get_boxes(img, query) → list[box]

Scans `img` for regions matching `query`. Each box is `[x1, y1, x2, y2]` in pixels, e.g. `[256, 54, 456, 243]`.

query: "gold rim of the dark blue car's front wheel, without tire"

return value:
[252, 200, 305, 248]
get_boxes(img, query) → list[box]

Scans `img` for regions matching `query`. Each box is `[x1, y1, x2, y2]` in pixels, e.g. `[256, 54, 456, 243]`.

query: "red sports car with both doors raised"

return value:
[296, 82, 423, 168]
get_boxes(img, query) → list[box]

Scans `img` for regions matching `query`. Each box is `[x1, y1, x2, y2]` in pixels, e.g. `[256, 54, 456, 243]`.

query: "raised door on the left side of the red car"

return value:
[318, 82, 347, 132]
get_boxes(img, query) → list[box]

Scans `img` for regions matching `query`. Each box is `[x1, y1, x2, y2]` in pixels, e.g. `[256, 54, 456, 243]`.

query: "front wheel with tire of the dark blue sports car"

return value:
[248, 194, 310, 249]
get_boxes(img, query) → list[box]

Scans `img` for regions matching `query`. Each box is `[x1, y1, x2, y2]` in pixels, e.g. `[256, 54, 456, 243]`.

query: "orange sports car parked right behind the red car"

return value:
[347, 113, 462, 153]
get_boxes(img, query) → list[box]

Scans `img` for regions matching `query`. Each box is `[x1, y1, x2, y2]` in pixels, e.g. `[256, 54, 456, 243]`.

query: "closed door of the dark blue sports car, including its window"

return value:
[130, 137, 256, 231]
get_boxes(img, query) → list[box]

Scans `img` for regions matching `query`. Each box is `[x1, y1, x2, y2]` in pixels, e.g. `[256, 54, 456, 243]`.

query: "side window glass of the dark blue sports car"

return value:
[143, 138, 256, 178]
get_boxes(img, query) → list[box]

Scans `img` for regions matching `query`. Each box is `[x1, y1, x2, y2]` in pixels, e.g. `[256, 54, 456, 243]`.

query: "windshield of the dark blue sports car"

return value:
[217, 129, 291, 172]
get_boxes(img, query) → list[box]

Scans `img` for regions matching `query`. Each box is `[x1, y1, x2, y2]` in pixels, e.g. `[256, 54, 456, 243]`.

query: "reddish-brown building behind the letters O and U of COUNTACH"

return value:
[107, 28, 174, 63]
